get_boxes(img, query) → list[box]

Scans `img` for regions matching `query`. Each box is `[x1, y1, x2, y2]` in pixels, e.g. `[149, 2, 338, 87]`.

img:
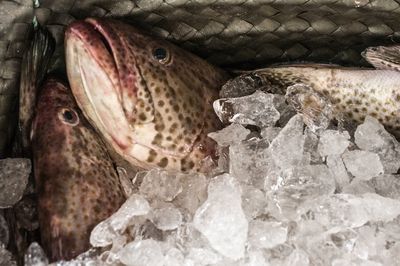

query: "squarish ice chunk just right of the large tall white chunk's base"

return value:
[249, 220, 288, 248]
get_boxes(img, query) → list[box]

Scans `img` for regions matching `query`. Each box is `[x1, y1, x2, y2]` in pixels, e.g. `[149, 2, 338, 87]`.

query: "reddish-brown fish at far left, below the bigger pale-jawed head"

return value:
[31, 78, 125, 261]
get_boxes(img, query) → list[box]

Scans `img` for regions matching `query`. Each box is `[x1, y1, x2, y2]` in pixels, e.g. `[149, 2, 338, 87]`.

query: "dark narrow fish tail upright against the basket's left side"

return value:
[18, 19, 56, 152]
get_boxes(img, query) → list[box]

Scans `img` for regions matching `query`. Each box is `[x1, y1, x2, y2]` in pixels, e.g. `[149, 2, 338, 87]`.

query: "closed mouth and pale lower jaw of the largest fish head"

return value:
[65, 18, 131, 150]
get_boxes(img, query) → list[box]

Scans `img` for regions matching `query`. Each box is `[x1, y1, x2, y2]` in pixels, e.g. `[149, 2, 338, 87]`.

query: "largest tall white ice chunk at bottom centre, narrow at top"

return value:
[193, 174, 248, 260]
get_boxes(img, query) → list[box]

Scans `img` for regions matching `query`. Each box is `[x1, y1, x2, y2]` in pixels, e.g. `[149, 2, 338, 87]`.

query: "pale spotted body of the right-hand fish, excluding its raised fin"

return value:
[253, 64, 400, 137]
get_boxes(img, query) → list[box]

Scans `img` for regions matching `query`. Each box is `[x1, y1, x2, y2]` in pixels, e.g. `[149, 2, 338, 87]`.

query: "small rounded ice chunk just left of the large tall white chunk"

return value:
[151, 204, 182, 231]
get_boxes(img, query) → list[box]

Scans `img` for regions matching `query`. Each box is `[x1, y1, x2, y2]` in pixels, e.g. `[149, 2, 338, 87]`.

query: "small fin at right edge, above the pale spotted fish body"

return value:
[361, 45, 400, 71]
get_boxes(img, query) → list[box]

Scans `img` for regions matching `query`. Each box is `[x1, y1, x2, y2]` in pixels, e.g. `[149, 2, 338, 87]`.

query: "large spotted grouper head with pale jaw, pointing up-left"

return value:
[65, 18, 227, 171]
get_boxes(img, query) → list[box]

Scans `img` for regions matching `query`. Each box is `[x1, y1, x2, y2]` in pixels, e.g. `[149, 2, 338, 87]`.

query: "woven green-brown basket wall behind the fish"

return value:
[0, 0, 400, 157]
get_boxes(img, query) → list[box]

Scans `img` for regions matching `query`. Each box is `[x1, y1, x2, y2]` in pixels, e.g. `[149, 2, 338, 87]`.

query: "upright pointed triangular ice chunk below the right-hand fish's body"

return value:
[270, 115, 305, 169]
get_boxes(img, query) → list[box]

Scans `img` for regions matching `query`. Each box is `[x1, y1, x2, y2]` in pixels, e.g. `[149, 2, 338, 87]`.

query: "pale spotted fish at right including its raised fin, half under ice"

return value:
[222, 45, 400, 138]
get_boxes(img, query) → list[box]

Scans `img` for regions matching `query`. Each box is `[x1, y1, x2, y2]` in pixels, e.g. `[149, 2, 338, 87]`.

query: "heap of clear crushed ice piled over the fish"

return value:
[7, 80, 400, 266]
